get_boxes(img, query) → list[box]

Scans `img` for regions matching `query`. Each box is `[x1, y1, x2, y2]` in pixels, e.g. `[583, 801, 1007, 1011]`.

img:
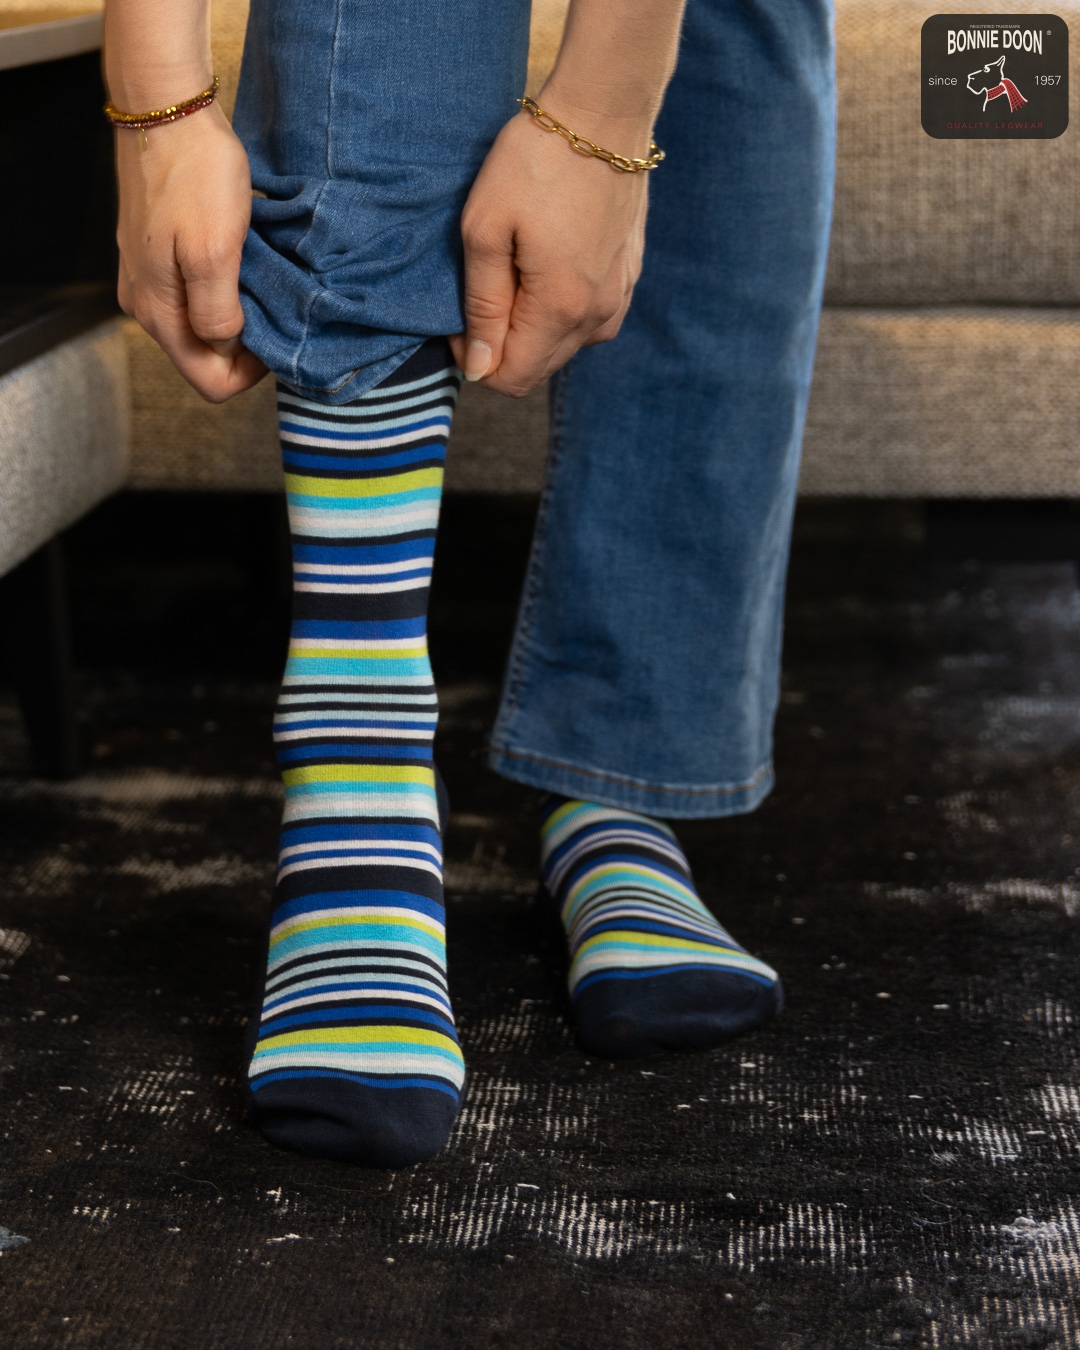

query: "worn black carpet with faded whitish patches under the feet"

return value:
[0, 498, 1080, 1350]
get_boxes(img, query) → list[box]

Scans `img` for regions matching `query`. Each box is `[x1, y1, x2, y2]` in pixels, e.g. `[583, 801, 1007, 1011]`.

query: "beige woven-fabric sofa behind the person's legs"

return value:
[118, 0, 1080, 497]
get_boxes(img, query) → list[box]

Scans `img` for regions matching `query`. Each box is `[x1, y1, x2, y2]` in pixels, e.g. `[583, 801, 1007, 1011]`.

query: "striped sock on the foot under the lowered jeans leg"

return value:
[541, 797, 783, 1058]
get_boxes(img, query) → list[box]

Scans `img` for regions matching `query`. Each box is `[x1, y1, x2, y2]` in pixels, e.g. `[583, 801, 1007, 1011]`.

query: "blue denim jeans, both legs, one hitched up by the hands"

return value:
[236, 0, 834, 818]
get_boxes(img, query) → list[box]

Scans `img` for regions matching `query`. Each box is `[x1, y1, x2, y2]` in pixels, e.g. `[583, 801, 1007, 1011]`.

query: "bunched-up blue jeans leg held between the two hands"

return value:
[234, 0, 529, 404]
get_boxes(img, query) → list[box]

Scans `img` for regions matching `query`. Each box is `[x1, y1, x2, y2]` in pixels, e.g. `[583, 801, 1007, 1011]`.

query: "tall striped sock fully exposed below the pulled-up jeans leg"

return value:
[248, 339, 464, 1168]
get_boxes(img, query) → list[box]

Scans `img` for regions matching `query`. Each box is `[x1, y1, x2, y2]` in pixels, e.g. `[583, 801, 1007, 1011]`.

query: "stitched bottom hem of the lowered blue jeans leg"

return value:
[486, 745, 774, 821]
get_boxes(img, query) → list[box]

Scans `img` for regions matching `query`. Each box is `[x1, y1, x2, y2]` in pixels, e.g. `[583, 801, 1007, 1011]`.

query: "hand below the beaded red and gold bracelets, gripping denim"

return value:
[116, 104, 266, 404]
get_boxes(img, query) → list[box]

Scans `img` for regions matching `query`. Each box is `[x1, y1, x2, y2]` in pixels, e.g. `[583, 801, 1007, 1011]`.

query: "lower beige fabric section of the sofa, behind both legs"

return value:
[128, 306, 1080, 497]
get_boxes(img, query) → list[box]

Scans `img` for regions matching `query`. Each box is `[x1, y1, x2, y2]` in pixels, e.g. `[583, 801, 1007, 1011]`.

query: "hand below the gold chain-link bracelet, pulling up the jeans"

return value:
[451, 95, 650, 398]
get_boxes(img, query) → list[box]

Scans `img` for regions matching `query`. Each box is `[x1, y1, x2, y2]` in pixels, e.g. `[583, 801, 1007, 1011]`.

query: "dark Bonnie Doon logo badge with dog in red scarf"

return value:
[922, 14, 1069, 140]
